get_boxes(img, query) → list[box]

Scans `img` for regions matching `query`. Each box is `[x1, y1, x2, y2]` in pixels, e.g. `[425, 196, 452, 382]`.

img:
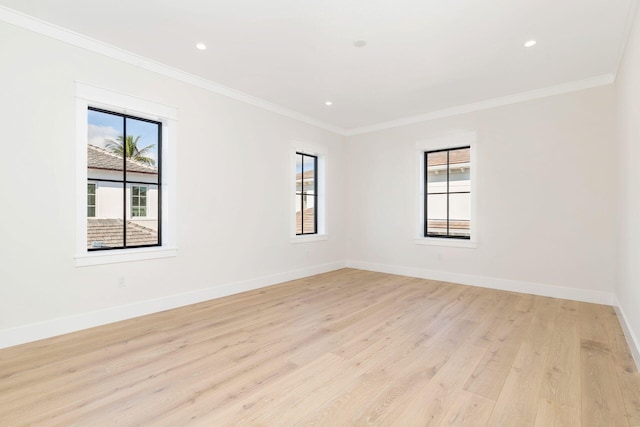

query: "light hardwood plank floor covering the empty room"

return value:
[0, 269, 640, 427]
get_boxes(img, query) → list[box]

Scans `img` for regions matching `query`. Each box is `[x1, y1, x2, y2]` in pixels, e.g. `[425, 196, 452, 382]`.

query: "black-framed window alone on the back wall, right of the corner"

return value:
[424, 146, 471, 239]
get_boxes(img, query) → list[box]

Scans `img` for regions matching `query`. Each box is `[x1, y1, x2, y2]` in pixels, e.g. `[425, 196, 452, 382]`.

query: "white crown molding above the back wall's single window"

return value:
[346, 74, 615, 136]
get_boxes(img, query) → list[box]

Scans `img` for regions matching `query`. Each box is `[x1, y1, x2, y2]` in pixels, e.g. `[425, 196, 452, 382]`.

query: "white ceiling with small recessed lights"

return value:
[0, 0, 636, 131]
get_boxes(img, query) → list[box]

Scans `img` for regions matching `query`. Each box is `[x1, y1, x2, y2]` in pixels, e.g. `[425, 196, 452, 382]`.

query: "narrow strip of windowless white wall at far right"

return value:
[616, 1, 640, 366]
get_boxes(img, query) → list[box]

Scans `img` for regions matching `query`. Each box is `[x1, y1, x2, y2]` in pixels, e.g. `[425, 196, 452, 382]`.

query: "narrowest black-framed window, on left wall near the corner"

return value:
[296, 152, 318, 236]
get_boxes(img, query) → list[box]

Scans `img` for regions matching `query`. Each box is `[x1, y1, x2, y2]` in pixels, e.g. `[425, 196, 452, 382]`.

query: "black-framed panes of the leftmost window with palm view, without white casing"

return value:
[87, 107, 162, 251]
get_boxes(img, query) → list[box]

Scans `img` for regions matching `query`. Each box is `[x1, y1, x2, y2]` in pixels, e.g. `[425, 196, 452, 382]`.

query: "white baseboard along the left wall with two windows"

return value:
[0, 261, 346, 348]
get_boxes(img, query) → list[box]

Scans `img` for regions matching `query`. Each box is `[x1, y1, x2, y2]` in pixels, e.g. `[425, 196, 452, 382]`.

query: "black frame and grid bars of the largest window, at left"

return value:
[87, 106, 162, 252]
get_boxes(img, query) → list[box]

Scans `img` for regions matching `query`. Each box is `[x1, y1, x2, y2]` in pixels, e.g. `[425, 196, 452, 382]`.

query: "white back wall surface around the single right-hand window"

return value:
[347, 86, 617, 303]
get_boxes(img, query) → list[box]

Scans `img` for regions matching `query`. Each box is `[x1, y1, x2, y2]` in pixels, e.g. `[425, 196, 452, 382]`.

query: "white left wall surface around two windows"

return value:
[0, 23, 345, 347]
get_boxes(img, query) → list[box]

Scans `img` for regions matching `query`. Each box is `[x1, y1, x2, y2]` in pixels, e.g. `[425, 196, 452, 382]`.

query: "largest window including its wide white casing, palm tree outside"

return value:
[74, 82, 178, 267]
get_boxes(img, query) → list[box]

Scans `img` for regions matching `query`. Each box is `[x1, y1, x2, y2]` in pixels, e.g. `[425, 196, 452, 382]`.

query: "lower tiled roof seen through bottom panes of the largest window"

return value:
[87, 218, 158, 248]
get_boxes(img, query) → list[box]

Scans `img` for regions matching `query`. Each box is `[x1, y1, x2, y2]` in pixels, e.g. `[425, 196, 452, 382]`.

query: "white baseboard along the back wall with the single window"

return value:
[347, 260, 614, 305]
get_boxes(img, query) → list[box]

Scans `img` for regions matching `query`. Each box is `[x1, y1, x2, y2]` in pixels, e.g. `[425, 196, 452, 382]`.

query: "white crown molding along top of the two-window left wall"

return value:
[0, 6, 345, 135]
